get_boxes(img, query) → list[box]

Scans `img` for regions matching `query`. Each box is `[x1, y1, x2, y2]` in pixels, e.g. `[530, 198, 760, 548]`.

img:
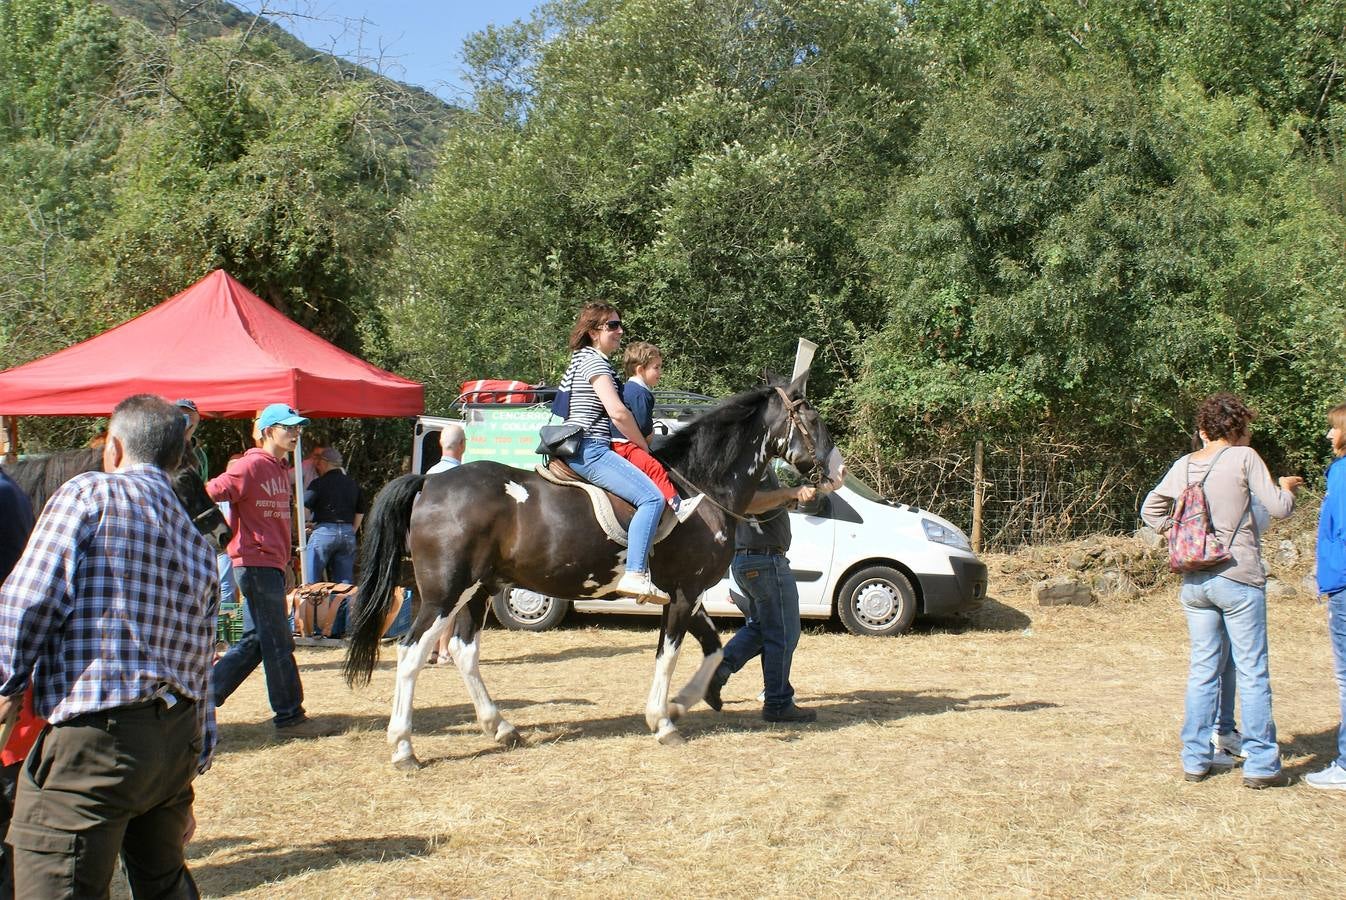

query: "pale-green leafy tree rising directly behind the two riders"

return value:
[388, 0, 919, 411]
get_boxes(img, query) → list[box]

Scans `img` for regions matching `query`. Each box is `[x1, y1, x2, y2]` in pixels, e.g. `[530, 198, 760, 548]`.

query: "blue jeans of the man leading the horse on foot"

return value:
[716, 553, 800, 712]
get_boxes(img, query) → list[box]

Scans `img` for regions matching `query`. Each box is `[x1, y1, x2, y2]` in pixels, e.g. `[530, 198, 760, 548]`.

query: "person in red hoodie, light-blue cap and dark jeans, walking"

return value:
[206, 404, 332, 739]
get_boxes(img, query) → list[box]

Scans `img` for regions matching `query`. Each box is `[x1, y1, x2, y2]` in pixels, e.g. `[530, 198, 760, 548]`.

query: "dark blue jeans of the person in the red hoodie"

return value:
[210, 566, 304, 726]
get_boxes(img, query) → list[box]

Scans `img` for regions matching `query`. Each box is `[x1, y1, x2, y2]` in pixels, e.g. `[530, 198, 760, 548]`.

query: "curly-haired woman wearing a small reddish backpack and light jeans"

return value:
[1140, 393, 1303, 788]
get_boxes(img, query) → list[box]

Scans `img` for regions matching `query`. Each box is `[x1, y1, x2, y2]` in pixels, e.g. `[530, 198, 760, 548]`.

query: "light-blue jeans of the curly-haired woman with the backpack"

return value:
[1182, 573, 1280, 778]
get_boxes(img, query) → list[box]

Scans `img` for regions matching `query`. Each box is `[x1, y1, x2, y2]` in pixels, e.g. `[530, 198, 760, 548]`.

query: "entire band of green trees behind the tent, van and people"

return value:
[0, 0, 1346, 503]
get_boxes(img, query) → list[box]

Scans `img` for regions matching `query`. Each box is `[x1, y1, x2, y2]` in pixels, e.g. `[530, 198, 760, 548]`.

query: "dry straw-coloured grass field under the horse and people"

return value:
[190, 581, 1346, 899]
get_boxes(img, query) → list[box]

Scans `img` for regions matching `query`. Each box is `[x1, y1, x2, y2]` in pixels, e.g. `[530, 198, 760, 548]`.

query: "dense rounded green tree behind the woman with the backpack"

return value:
[855, 59, 1346, 476]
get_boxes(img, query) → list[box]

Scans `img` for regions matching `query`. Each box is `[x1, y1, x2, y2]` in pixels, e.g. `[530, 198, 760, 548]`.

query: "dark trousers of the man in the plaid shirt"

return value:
[8, 701, 201, 899]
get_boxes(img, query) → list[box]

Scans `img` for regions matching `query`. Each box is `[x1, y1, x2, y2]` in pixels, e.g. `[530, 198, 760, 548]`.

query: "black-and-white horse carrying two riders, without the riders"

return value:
[346, 377, 843, 770]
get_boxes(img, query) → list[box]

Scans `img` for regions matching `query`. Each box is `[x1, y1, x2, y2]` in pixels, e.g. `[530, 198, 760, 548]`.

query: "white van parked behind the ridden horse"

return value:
[412, 397, 987, 635]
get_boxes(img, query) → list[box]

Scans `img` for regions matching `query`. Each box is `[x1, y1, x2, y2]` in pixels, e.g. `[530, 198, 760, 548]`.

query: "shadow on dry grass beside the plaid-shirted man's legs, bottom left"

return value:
[187, 834, 436, 897]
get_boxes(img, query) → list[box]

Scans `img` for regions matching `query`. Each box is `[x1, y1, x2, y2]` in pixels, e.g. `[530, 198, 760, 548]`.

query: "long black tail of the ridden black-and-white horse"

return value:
[345, 475, 425, 687]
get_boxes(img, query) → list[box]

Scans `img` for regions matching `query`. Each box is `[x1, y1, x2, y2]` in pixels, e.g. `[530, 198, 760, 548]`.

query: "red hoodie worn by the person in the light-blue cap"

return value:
[206, 447, 295, 569]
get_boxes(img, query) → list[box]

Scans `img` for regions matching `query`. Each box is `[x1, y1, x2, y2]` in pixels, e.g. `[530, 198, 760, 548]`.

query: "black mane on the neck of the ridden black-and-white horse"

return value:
[654, 385, 775, 484]
